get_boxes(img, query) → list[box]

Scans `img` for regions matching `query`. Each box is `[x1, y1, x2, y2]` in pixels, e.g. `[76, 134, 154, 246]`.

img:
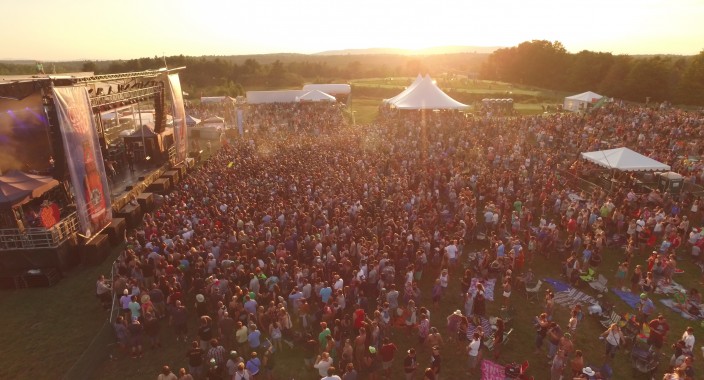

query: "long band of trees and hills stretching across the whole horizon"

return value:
[0, 40, 704, 106]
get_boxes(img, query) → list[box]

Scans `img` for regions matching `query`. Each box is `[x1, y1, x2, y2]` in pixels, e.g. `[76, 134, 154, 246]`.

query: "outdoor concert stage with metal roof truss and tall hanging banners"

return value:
[0, 68, 187, 288]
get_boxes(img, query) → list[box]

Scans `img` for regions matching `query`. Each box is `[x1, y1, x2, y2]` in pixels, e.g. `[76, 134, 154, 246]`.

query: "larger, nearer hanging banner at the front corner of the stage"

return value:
[54, 87, 112, 237]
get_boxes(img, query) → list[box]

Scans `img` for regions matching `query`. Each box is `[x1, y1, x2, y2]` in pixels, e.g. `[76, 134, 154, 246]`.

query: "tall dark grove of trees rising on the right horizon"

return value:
[480, 40, 704, 106]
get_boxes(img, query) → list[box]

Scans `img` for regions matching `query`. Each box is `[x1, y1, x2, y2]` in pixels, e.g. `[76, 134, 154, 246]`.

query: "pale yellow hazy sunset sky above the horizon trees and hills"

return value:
[0, 0, 704, 61]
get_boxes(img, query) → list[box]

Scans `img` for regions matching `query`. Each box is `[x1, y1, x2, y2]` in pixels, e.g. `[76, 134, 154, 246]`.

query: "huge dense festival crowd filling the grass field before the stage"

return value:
[98, 103, 704, 380]
